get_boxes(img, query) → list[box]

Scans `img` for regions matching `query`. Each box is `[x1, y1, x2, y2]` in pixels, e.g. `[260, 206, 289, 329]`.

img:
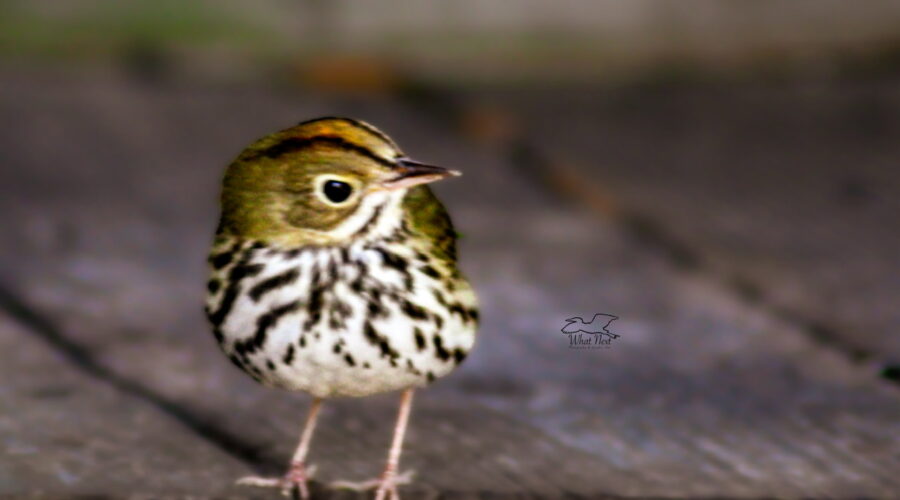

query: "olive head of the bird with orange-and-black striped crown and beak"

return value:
[219, 118, 459, 246]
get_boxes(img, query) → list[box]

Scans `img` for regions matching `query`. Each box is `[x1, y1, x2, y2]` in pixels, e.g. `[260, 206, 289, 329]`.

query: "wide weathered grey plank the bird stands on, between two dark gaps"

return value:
[0, 69, 900, 497]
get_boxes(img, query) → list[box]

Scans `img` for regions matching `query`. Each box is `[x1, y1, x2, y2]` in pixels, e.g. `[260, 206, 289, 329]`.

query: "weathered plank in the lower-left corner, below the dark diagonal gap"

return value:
[0, 314, 249, 497]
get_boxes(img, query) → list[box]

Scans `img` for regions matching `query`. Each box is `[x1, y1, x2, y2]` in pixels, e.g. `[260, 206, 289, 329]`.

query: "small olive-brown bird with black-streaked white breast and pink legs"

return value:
[205, 117, 479, 500]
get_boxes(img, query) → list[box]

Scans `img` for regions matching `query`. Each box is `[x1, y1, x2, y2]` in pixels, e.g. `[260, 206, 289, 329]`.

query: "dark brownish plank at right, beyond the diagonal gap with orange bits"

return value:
[494, 81, 900, 368]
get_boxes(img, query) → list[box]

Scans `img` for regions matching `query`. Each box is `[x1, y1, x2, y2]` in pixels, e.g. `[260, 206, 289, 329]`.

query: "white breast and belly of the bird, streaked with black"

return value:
[209, 242, 476, 397]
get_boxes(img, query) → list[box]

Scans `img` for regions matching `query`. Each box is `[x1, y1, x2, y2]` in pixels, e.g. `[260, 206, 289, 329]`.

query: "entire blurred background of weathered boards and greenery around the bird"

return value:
[0, 0, 900, 498]
